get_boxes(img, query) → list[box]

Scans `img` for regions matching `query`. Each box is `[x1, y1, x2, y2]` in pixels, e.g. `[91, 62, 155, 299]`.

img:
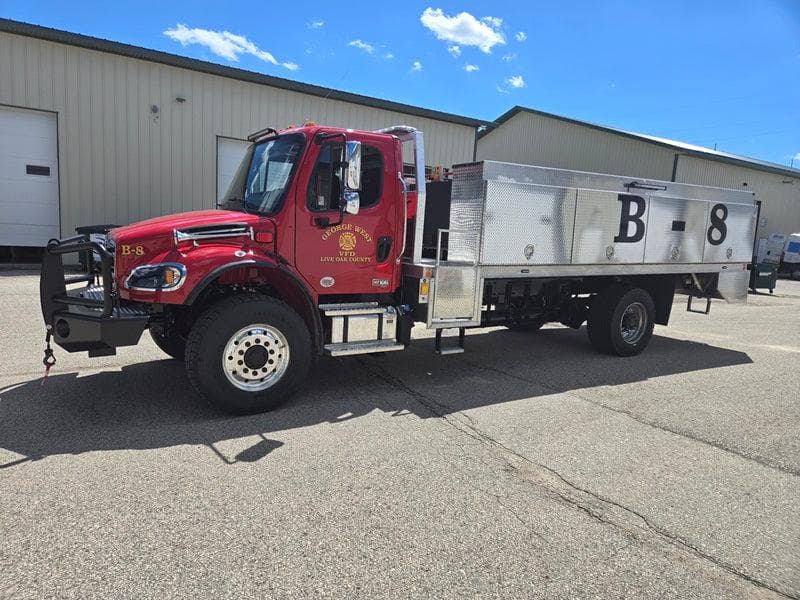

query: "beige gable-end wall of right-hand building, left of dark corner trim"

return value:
[478, 112, 675, 180]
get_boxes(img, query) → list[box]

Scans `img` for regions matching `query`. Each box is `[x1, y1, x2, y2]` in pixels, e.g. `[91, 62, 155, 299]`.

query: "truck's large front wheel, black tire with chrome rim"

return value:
[186, 294, 312, 414]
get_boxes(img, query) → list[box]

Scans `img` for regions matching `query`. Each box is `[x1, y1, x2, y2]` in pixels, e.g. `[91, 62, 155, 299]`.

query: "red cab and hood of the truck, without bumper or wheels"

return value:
[109, 126, 412, 304]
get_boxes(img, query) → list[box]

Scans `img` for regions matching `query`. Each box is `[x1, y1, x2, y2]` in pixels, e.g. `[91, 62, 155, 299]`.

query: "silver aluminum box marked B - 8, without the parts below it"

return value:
[448, 161, 756, 266]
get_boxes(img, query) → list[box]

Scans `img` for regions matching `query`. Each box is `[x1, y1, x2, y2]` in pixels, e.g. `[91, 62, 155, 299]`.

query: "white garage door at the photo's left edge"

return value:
[0, 106, 59, 246]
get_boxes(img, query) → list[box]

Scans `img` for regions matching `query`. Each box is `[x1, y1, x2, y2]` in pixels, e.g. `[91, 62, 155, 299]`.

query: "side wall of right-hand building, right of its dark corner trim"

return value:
[675, 156, 800, 237]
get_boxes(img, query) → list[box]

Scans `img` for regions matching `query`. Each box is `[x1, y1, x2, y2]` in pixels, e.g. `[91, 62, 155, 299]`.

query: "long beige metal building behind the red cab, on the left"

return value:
[0, 19, 482, 246]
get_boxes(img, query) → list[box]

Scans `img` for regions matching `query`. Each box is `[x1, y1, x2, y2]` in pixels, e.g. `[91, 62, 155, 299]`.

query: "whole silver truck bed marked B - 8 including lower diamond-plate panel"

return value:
[428, 161, 757, 327]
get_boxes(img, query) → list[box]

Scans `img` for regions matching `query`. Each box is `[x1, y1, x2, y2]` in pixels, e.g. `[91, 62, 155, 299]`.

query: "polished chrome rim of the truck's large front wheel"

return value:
[222, 323, 289, 392]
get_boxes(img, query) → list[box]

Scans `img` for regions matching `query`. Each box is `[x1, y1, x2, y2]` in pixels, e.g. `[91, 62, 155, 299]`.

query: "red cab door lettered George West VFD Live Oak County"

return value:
[295, 136, 402, 294]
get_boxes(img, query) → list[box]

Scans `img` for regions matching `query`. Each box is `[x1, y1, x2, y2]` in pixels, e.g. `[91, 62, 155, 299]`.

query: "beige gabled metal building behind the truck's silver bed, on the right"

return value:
[477, 106, 800, 237]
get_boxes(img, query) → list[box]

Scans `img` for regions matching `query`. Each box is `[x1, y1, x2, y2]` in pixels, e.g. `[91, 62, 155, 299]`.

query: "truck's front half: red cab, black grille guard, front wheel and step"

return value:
[41, 125, 424, 412]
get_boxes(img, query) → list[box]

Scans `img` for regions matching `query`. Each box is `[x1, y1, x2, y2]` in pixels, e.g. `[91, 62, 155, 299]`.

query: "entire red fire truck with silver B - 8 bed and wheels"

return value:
[40, 125, 756, 413]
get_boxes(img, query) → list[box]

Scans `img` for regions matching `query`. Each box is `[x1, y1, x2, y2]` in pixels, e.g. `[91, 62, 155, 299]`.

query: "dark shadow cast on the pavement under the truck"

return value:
[0, 329, 752, 469]
